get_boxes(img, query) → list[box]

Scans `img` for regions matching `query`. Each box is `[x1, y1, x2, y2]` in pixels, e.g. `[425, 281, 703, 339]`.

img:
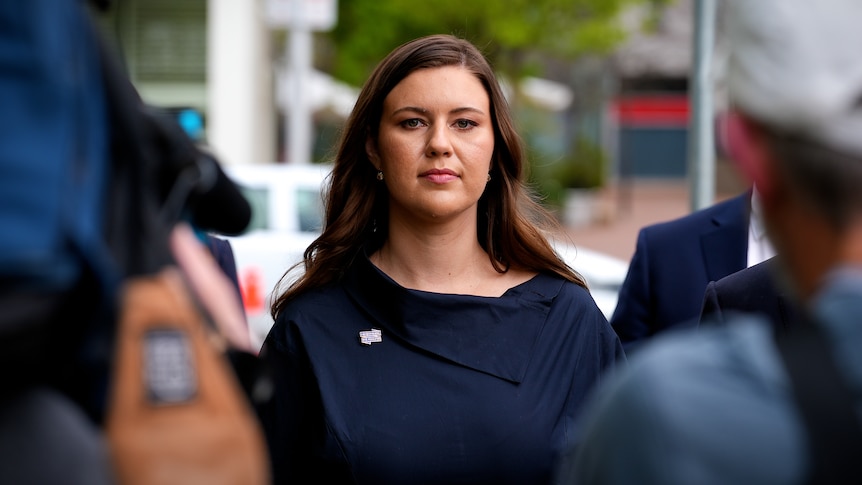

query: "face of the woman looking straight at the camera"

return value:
[366, 66, 494, 226]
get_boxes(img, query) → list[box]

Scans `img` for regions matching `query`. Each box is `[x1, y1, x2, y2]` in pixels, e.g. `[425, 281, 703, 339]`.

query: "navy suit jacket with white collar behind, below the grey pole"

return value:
[610, 191, 751, 351]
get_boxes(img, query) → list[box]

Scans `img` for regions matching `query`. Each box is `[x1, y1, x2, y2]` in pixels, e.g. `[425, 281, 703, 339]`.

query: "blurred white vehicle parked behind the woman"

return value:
[224, 164, 628, 346]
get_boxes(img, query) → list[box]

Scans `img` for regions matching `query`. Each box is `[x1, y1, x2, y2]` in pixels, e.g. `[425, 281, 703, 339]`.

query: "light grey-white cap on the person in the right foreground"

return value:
[724, 0, 862, 154]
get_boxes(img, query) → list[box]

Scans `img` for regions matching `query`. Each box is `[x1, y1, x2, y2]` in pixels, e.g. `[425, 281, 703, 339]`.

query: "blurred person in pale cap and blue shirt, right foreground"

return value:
[561, 0, 862, 485]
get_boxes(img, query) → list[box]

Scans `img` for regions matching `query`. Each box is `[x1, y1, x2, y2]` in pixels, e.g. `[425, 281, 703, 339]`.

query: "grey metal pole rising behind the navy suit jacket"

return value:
[688, 0, 716, 211]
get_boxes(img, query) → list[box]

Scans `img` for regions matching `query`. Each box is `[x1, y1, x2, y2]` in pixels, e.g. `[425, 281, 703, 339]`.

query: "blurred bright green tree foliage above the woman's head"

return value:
[318, 0, 668, 85]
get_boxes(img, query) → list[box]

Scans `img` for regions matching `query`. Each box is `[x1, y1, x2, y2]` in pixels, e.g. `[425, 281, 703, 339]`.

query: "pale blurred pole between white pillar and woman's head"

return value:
[285, 0, 311, 164]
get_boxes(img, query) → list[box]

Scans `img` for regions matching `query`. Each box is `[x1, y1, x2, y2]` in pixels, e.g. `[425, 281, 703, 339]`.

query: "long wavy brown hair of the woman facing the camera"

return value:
[272, 35, 586, 318]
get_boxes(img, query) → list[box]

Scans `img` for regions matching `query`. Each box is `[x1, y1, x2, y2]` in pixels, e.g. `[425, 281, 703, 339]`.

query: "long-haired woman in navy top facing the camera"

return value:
[261, 35, 622, 484]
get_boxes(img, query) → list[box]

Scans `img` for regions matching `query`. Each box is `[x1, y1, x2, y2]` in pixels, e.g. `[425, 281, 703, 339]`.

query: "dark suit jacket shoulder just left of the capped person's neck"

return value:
[700, 258, 798, 332]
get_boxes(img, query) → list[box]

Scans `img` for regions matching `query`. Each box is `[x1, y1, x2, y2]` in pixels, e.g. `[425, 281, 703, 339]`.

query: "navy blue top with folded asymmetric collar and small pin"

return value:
[260, 251, 624, 484]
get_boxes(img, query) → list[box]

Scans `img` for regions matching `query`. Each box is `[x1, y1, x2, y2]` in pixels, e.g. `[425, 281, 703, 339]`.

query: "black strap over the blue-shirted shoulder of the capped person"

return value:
[776, 320, 862, 484]
